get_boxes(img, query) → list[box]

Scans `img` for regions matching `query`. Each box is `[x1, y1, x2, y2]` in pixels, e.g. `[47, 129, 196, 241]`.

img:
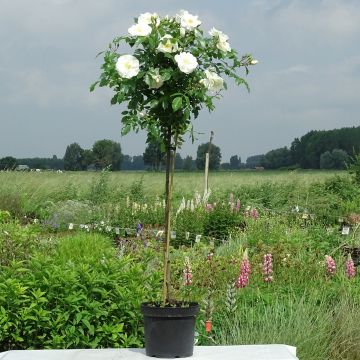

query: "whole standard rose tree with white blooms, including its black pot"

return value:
[90, 11, 257, 357]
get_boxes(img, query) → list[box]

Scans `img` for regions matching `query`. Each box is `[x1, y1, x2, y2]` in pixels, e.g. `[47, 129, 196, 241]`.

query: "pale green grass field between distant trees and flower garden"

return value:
[0, 171, 346, 215]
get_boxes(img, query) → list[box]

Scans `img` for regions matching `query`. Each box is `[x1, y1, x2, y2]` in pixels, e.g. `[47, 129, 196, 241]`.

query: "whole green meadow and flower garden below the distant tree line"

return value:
[0, 171, 360, 360]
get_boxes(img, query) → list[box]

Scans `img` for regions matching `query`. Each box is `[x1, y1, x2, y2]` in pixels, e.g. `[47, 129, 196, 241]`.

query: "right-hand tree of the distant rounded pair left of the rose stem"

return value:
[92, 139, 123, 171]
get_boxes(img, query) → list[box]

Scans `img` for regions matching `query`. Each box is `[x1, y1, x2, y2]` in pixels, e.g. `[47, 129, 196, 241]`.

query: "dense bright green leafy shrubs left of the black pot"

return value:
[0, 234, 160, 350]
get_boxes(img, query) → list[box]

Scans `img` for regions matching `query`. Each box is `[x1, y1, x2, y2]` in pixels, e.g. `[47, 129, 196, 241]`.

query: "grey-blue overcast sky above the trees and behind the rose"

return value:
[0, 0, 360, 162]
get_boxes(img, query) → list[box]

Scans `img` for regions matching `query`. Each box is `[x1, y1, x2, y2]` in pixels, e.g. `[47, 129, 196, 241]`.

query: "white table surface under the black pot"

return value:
[0, 345, 298, 360]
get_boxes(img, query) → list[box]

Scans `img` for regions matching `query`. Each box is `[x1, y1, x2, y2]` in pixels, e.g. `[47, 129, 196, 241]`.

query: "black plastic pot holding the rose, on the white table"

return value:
[141, 303, 199, 358]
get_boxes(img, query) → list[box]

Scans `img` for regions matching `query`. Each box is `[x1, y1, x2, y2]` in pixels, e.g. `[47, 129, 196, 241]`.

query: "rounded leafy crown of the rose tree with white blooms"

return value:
[90, 11, 257, 146]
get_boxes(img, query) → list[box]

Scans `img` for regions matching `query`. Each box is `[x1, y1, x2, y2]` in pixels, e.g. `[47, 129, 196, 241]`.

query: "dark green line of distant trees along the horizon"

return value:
[0, 126, 360, 171]
